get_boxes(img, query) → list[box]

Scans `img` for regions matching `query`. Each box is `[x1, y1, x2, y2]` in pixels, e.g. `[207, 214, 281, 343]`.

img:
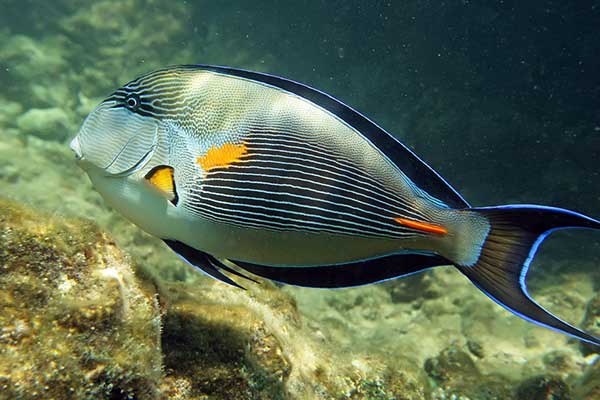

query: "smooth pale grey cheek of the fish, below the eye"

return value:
[77, 101, 159, 175]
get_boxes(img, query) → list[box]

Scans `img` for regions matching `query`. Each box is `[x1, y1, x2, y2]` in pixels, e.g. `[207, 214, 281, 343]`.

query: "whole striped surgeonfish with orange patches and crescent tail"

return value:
[70, 65, 600, 346]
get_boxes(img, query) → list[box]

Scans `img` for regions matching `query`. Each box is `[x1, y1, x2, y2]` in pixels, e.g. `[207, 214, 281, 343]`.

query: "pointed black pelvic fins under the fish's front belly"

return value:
[163, 239, 258, 290]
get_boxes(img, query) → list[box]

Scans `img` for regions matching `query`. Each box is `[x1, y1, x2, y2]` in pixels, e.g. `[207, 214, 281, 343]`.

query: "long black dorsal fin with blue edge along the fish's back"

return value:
[182, 64, 469, 208]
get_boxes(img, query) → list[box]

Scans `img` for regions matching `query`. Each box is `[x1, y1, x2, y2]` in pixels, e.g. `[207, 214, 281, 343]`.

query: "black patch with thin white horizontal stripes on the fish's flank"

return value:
[184, 129, 436, 238]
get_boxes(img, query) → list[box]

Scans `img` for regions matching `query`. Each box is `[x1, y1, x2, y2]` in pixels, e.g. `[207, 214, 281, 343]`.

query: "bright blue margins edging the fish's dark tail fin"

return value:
[468, 204, 600, 346]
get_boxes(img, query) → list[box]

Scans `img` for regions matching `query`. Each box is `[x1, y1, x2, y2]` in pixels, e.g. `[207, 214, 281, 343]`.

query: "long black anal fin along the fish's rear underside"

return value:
[232, 254, 451, 288]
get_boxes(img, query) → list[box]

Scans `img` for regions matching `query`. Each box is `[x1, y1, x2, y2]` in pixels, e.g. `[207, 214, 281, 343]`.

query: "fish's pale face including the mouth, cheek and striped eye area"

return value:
[70, 85, 160, 176]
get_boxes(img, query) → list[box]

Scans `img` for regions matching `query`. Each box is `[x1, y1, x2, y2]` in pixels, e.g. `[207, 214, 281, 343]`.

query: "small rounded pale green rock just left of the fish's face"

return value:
[17, 107, 72, 141]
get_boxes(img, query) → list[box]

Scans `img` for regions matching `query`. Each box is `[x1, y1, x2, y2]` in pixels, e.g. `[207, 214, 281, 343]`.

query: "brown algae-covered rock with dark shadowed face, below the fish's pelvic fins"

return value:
[161, 283, 291, 399]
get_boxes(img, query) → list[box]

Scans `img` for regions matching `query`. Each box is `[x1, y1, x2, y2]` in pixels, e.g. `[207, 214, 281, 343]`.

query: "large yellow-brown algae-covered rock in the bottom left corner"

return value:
[0, 200, 162, 399]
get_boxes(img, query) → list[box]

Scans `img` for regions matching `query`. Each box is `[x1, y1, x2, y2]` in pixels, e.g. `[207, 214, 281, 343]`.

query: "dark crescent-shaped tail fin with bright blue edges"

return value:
[457, 205, 600, 346]
